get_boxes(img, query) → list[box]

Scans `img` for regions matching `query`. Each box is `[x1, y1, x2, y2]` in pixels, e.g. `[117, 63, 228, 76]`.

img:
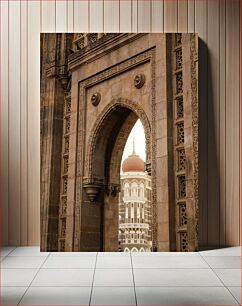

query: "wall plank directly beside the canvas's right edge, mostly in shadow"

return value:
[195, 0, 208, 246]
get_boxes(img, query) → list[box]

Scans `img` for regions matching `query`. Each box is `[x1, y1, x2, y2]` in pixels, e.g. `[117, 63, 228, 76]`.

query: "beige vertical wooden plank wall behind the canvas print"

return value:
[1, 0, 240, 246]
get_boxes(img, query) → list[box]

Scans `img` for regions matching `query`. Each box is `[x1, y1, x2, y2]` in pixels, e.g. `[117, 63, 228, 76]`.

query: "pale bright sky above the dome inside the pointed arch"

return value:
[122, 119, 145, 167]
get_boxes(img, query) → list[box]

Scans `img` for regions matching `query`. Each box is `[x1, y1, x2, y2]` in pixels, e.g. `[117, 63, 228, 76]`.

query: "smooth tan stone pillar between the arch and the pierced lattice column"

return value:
[155, 34, 175, 251]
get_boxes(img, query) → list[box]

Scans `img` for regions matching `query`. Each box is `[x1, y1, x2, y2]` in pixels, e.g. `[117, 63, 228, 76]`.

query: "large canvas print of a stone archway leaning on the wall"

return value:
[40, 33, 199, 252]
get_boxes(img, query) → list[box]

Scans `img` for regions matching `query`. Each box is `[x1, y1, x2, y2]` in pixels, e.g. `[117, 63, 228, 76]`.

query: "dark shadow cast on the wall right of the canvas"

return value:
[198, 39, 220, 249]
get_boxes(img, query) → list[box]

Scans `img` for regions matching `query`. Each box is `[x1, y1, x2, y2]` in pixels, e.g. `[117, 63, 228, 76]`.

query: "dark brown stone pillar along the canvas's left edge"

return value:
[40, 33, 72, 251]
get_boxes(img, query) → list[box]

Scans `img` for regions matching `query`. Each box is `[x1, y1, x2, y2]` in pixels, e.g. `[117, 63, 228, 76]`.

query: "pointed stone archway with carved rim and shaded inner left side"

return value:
[83, 97, 151, 251]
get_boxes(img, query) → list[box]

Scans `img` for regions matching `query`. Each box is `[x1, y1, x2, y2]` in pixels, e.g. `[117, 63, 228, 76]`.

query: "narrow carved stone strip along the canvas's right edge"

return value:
[182, 34, 198, 251]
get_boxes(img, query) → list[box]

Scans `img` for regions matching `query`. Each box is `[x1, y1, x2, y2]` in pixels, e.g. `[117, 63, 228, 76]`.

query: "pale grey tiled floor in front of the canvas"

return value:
[0, 247, 241, 306]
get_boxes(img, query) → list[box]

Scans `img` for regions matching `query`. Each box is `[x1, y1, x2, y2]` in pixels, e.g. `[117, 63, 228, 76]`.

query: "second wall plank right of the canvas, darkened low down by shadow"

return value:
[207, 1, 220, 246]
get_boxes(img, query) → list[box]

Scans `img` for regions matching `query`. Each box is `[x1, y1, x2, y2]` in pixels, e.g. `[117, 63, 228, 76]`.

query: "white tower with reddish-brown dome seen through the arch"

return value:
[119, 141, 152, 252]
